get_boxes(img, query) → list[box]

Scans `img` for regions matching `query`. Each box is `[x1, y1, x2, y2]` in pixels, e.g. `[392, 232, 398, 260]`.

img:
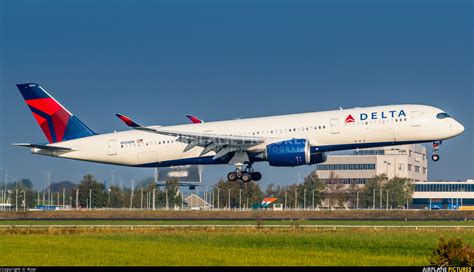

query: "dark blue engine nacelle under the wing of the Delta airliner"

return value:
[266, 139, 311, 166]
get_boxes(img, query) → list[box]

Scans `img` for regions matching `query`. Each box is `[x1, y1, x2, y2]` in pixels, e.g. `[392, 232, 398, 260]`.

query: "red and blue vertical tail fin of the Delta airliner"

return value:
[16, 83, 96, 143]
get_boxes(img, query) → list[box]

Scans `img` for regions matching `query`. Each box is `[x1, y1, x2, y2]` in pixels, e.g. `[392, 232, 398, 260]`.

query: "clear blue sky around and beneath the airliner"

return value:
[0, 0, 474, 191]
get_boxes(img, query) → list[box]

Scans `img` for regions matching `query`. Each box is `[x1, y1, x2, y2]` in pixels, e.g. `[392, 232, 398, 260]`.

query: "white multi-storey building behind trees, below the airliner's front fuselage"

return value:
[316, 144, 428, 184]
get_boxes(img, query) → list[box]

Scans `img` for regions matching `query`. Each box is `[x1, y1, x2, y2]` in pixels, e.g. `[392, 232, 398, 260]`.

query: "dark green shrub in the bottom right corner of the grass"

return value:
[428, 237, 474, 266]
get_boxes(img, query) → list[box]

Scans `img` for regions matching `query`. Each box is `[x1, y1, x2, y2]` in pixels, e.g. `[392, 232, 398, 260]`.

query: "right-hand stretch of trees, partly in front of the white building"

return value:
[211, 171, 414, 209]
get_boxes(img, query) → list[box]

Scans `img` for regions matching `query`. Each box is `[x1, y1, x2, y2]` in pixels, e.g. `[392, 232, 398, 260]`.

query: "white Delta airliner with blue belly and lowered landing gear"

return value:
[15, 83, 464, 182]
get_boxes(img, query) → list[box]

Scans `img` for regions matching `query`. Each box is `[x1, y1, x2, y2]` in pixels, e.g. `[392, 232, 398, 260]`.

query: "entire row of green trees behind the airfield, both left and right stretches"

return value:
[2, 171, 414, 209]
